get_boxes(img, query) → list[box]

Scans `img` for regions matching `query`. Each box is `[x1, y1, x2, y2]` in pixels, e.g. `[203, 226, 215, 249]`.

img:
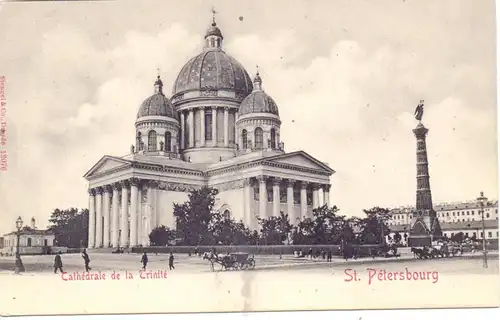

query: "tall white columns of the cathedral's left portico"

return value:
[88, 178, 158, 248]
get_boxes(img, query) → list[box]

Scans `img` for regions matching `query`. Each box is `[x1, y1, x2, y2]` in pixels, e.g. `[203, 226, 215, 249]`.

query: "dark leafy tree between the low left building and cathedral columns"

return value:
[49, 208, 89, 248]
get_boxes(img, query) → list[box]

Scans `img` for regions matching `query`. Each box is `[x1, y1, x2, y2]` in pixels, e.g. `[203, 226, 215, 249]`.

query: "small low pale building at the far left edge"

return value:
[0, 218, 55, 255]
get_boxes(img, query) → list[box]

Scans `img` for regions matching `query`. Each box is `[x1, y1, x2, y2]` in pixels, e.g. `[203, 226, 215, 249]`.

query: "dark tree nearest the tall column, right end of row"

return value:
[357, 207, 391, 244]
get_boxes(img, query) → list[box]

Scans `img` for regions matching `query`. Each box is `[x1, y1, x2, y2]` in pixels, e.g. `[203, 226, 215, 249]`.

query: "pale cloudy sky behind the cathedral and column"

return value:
[0, 0, 498, 233]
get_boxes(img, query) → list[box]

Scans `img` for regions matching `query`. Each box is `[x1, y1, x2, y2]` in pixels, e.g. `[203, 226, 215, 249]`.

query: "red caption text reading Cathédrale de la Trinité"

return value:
[61, 270, 167, 281]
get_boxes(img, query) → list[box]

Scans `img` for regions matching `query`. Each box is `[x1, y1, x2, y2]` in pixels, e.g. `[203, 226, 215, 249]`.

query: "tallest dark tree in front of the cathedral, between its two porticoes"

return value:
[174, 187, 218, 246]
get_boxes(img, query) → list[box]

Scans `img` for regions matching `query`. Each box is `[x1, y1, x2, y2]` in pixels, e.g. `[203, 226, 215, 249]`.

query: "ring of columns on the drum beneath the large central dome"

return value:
[179, 106, 238, 149]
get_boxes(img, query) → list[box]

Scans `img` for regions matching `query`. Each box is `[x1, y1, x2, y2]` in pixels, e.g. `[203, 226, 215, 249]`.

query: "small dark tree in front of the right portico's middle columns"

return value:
[259, 212, 292, 245]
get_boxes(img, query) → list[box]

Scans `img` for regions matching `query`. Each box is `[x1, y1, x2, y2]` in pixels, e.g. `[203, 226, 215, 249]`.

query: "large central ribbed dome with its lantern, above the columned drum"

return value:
[172, 21, 253, 97]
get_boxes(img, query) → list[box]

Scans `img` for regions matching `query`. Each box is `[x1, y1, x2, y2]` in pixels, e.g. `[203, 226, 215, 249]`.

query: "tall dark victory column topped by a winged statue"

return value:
[408, 100, 443, 247]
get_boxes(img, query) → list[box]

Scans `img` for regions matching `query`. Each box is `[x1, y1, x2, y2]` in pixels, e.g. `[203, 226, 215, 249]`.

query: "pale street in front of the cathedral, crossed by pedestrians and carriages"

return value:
[0, 252, 499, 274]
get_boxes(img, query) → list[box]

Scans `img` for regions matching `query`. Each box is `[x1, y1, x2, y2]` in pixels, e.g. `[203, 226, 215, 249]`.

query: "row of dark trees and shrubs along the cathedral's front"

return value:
[149, 187, 394, 246]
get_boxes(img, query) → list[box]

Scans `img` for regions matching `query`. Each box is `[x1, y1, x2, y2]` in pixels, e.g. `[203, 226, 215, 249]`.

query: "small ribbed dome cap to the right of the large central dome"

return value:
[238, 73, 279, 117]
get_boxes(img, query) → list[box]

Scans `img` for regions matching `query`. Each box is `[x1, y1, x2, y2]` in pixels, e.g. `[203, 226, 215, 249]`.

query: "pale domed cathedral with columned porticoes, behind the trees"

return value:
[84, 20, 334, 248]
